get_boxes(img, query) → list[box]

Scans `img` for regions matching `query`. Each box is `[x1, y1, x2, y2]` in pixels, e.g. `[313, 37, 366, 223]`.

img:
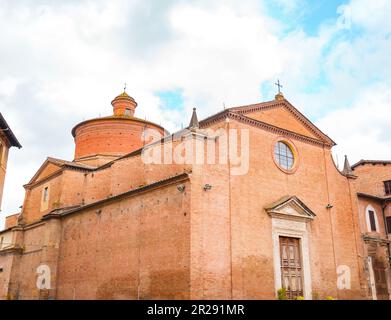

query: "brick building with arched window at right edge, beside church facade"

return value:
[352, 160, 391, 300]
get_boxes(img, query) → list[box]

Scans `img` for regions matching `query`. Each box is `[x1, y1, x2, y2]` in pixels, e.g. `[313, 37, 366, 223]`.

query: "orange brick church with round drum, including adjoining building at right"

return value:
[0, 92, 391, 299]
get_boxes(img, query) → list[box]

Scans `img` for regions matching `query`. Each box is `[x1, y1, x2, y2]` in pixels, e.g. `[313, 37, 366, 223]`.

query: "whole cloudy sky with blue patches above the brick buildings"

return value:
[0, 0, 391, 227]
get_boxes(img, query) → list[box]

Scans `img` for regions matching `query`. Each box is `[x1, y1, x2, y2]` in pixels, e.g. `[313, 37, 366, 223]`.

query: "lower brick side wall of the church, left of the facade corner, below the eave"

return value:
[0, 180, 190, 299]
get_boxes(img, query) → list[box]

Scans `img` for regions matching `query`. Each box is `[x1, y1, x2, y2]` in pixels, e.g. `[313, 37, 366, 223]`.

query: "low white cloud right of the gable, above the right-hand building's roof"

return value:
[317, 86, 391, 165]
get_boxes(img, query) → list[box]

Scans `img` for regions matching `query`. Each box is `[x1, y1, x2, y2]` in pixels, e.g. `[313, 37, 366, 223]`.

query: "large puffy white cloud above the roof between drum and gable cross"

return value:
[159, 6, 284, 109]
